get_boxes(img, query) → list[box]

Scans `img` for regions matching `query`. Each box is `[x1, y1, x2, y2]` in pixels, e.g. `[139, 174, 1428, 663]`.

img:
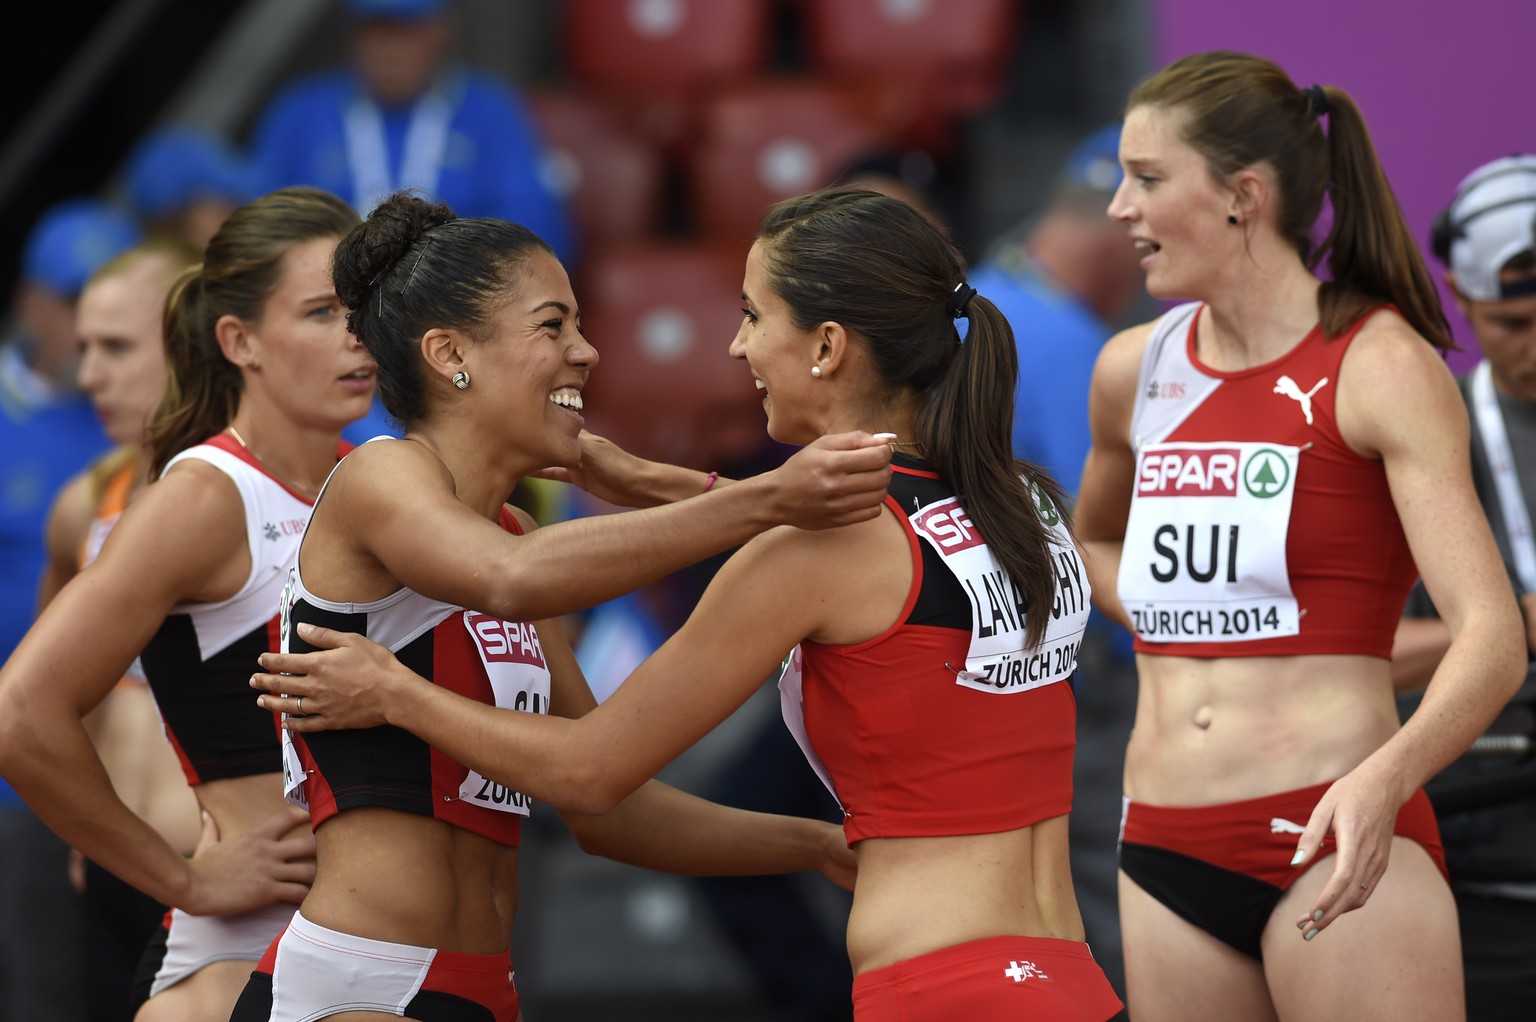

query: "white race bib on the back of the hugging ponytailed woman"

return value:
[911, 487, 1091, 695]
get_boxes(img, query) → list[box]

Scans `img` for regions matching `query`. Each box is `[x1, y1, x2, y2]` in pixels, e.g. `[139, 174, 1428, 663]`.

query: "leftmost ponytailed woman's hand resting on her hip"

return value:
[177, 807, 315, 916]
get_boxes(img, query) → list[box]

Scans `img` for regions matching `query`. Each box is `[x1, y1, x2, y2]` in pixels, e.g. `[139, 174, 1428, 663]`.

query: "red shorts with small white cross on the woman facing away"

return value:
[854, 937, 1121, 1022]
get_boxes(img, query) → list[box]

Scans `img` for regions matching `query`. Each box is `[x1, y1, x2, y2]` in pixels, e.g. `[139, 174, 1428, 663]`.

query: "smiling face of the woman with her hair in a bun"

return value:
[460, 251, 598, 466]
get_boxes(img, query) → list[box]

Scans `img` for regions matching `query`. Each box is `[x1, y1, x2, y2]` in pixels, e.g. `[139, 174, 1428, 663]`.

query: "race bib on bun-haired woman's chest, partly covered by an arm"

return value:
[459, 610, 550, 816]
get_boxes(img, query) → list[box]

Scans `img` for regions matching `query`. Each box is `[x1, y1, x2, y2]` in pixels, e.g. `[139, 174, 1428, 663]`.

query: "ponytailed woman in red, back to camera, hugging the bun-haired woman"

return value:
[252, 189, 1120, 1022]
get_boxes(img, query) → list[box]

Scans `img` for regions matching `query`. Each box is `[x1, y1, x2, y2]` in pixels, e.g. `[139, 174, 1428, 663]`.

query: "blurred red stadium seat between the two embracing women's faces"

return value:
[581, 241, 766, 469]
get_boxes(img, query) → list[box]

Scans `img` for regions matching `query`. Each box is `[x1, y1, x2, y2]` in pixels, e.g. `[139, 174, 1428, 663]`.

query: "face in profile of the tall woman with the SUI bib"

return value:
[1109, 106, 1243, 298]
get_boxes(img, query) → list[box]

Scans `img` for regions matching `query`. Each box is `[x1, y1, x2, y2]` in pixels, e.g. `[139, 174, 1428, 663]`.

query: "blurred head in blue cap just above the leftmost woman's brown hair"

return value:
[127, 128, 267, 252]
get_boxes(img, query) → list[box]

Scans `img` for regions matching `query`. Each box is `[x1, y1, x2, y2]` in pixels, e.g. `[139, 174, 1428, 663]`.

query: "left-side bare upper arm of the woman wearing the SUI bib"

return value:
[1072, 323, 1154, 541]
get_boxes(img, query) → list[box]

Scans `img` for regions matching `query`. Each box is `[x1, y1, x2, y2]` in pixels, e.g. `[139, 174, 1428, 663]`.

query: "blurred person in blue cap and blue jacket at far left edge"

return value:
[0, 200, 138, 1020]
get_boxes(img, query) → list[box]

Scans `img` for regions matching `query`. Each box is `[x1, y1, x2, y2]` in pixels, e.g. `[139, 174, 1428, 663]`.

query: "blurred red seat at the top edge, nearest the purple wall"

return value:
[800, 0, 1023, 144]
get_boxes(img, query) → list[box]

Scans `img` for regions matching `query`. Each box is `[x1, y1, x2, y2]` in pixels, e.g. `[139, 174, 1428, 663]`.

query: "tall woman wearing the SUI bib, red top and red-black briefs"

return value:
[1077, 52, 1524, 1022]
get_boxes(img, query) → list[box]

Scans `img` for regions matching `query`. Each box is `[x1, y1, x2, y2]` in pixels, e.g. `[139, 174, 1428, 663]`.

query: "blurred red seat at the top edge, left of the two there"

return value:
[564, 0, 773, 144]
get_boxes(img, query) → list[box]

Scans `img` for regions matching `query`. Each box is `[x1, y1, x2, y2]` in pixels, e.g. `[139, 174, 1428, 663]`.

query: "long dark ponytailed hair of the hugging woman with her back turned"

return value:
[757, 187, 1066, 645]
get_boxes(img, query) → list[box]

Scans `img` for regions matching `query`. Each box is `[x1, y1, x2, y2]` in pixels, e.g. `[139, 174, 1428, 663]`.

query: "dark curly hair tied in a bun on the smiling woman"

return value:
[332, 192, 554, 426]
